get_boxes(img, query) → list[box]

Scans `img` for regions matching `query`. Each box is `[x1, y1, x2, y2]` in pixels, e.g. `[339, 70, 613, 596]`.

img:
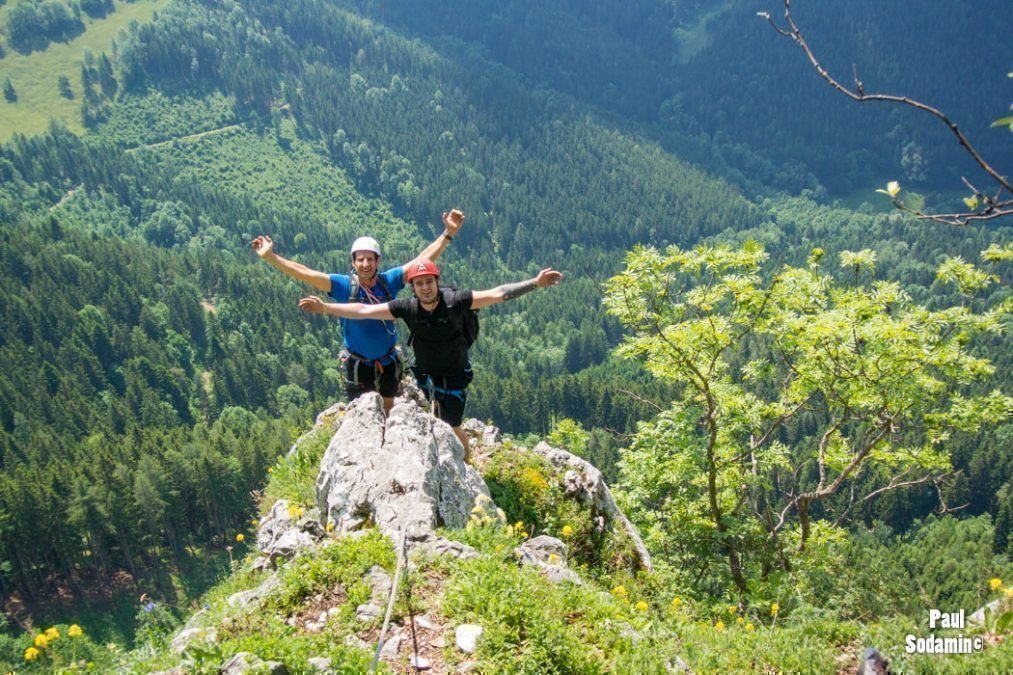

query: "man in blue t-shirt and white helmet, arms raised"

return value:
[250, 209, 464, 413]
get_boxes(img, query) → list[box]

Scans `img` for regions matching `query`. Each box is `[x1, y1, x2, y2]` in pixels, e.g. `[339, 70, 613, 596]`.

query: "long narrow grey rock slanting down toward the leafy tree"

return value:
[534, 441, 651, 571]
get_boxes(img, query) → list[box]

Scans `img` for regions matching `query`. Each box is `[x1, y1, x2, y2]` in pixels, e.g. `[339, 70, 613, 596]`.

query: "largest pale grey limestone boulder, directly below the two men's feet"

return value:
[316, 393, 488, 542]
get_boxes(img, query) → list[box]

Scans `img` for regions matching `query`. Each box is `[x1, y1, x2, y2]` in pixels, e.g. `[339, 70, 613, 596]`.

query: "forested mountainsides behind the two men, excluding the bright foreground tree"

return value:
[0, 0, 1013, 660]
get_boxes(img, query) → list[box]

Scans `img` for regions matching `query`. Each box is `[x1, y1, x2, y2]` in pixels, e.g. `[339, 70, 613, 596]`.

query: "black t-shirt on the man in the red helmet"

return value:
[387, 288, 472, 378]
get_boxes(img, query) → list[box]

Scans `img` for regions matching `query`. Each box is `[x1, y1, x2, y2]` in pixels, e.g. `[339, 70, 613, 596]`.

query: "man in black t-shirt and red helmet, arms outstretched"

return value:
[299, 259, 563, 460]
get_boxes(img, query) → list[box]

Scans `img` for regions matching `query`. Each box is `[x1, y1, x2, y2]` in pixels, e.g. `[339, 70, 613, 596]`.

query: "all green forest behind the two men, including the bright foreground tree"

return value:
[0, 0, 1013, 672]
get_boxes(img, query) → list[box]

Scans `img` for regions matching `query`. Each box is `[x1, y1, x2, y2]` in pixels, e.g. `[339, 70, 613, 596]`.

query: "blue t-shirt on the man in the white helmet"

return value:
[328, 267, 404, 361]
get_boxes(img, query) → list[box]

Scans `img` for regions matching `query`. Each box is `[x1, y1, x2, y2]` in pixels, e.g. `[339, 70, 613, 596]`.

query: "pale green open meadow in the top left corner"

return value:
[0, 0, 168, 141]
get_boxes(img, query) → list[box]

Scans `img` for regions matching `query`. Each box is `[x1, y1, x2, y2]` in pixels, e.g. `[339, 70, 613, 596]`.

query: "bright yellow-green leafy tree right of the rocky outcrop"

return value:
[606, 243, 1013, 602]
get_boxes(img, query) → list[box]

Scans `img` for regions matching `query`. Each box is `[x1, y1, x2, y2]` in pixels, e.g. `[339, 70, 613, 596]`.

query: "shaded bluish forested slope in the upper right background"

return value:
[346, 0, 1013, 195]
